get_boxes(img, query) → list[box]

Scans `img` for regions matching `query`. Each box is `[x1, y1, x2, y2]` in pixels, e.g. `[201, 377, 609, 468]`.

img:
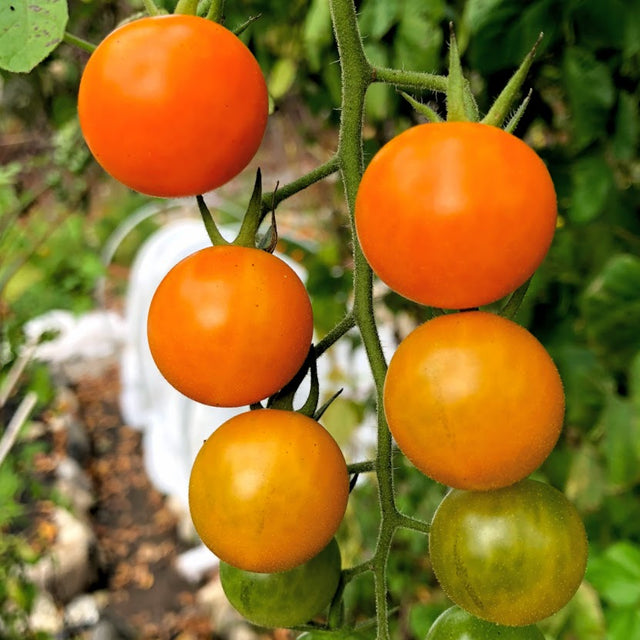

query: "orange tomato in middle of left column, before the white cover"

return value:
[147, 246, 313, 407]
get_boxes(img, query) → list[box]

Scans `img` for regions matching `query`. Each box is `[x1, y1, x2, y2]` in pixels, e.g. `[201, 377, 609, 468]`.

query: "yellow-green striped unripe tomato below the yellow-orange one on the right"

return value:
[429, 480, 588, 626]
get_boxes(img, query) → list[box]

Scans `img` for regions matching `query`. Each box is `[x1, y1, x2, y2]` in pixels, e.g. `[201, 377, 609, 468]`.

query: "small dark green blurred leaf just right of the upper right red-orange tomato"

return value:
[567, 153, 614, 224]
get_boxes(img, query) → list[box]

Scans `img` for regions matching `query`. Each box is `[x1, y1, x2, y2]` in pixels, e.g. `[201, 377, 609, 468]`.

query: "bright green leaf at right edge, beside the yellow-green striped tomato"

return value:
[586, 541, 640, 604]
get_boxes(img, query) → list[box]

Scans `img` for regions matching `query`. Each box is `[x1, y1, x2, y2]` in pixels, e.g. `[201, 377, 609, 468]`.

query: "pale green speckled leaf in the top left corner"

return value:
[0, 0, 69, 73]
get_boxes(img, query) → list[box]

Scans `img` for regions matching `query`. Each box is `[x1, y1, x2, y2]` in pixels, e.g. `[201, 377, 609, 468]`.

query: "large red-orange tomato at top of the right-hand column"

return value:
[355, 122, 557, 309]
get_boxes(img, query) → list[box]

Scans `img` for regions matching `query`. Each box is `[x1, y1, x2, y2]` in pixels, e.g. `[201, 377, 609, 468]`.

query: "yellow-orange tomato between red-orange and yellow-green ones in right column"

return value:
[384, 311, 564, 490]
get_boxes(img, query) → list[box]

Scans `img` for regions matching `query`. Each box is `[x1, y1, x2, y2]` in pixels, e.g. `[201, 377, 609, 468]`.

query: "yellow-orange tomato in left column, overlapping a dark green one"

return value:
[189, 409, 349, 573]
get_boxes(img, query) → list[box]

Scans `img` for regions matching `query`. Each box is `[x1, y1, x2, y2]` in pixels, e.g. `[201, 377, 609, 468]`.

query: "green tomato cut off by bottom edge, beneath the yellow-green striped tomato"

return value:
[425, 606, 544, 640]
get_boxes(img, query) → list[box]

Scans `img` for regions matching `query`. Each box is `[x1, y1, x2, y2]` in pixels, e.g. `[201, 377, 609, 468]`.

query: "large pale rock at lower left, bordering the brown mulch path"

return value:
[27, 507, 97, 603]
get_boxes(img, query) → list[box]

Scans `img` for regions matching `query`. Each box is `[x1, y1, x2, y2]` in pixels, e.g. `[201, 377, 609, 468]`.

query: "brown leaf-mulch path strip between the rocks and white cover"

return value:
[75, 367, 215, 640]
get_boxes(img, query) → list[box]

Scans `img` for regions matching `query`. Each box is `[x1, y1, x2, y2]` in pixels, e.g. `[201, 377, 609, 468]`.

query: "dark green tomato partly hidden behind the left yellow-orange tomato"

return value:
[220, 538, 342, 627]
